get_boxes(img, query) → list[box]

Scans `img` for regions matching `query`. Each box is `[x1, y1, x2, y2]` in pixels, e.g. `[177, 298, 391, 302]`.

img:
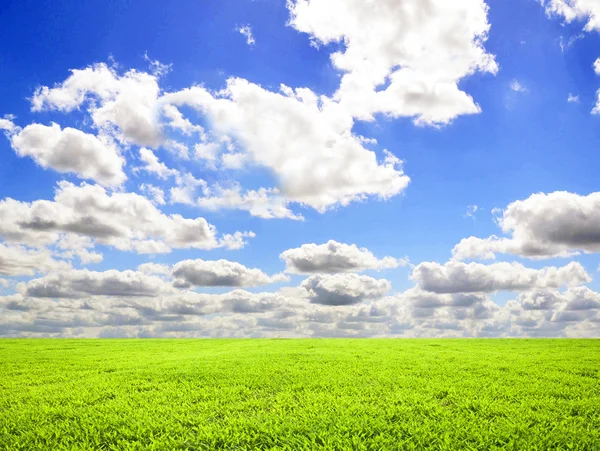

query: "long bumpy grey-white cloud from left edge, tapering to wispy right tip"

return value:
[0, 182, 254, 253]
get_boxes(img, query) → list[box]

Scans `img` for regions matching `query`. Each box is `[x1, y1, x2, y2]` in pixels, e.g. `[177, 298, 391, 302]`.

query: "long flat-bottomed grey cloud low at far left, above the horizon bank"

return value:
[17, 269, 170, 298]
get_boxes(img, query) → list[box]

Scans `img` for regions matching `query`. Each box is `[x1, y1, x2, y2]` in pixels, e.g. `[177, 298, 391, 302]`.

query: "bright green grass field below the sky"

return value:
[0, 339, 600, 451]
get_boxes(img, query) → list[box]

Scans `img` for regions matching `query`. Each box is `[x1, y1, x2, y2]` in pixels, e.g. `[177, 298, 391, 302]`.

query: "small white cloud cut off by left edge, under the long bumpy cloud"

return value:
[0, 243, 70, 276]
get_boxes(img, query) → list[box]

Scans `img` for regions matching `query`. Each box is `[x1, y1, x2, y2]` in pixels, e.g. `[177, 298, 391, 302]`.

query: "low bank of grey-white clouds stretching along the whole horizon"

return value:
[0, 264, 600, 337]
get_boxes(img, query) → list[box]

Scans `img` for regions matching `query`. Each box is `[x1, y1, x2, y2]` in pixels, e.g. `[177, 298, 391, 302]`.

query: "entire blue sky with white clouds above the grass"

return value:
[0, 0, 600, 337]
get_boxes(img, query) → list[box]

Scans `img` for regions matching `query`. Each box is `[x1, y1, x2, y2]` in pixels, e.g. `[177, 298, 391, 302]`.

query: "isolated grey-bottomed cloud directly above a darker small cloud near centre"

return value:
[280, 240, 408, 274]
